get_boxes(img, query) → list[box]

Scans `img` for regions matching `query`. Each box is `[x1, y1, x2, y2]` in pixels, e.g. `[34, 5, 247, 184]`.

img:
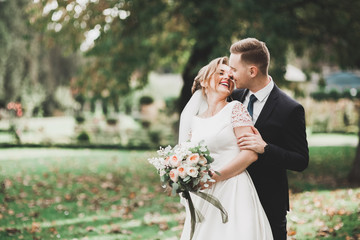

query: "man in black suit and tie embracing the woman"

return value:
[229, 38, 309, 240]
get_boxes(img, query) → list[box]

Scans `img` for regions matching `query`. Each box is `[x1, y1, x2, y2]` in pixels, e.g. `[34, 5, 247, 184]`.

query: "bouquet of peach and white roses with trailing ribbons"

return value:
[148, 141, 228, 238]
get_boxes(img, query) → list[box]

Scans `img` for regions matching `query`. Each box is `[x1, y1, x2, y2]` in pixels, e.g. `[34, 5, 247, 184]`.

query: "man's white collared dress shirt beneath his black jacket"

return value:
[243, 76, 275, 124]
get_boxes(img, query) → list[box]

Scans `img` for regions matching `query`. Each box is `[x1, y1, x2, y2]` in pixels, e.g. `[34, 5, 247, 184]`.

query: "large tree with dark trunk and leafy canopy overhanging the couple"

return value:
[32, 0, 360, 182]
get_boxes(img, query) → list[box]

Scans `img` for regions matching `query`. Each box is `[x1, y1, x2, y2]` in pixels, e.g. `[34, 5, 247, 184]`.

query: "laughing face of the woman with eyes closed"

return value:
[210, 64, 234, 97]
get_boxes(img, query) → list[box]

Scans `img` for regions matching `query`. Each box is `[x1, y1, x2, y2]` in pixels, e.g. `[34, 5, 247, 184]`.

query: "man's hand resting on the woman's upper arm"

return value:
[238, 126, 267, 154]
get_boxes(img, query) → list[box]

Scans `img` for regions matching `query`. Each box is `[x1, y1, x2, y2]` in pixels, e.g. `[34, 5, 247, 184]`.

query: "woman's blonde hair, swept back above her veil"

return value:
[191, 57, 229, 95]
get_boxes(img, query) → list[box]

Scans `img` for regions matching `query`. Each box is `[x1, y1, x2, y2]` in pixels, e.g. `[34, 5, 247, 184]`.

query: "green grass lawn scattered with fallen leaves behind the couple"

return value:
[0, 147, 360, 240]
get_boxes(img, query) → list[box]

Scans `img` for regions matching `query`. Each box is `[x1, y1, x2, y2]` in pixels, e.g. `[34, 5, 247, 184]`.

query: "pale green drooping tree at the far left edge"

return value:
[0, 0, 78, 116]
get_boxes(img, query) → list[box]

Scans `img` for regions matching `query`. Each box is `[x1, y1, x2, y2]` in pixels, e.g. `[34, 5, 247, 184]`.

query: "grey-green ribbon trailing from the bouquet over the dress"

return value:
[182, 191, 228, 240]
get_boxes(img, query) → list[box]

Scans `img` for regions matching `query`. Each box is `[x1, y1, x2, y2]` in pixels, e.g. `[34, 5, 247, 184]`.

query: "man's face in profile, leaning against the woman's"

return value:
[229, 53, 249, 88]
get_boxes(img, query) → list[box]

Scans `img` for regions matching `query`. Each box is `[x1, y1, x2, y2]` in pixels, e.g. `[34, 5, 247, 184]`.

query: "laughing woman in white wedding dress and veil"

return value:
[179, 57, 273, 240]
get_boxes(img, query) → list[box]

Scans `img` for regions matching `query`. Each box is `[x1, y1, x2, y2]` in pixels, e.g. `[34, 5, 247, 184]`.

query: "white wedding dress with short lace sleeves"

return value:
[181, 101, 273, 240]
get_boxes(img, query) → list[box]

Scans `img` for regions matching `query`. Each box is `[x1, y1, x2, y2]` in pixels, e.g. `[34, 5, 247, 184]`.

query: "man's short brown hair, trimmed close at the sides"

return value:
[230, 38, 270, 75]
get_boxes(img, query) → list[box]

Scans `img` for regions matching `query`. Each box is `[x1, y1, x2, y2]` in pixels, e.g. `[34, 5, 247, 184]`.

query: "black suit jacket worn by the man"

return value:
[232, 85, 309, 221]
